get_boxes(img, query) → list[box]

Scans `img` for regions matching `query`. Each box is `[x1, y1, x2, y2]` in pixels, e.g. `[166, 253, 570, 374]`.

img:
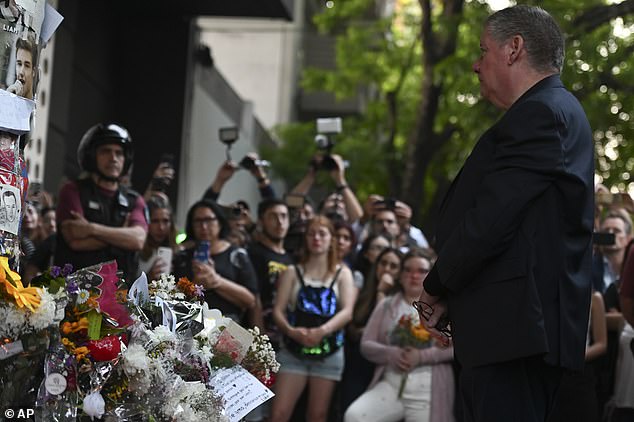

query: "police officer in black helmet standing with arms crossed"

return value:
[55, 124, 148, 283]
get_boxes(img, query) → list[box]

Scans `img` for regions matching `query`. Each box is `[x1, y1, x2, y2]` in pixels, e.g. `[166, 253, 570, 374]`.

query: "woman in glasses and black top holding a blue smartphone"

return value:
[174, 199, 257, 322]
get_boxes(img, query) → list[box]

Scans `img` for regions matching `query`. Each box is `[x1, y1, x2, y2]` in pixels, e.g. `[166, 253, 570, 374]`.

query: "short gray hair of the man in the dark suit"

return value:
[485, 5, 564, 73]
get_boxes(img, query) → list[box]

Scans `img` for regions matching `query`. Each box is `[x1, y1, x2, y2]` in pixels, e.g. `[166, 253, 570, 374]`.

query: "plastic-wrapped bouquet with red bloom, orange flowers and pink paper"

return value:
[37, 261, 133, 420]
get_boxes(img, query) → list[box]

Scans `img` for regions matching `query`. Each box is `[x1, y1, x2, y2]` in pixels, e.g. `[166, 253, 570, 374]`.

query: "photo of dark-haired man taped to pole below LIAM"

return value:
[0, 31, 39, 100]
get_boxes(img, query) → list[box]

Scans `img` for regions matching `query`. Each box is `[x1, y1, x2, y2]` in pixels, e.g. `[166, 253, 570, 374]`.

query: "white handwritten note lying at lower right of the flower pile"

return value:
[211, 366, 275, 422]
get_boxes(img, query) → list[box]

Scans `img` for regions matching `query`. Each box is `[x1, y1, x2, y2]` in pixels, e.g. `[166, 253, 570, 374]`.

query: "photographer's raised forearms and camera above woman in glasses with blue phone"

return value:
[203, 152, 275, 201]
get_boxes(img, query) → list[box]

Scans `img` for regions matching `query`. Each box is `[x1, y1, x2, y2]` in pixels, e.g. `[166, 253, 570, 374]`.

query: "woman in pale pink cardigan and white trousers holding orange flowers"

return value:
[345, 249, 454, 422]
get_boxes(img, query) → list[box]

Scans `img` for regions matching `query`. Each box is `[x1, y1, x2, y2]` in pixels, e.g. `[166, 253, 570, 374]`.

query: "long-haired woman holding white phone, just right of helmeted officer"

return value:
[139, 196, 176, 280]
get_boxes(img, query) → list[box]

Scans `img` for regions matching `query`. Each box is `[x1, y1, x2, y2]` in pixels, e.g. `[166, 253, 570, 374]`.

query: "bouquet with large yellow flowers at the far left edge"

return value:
[0, 256, 72, 407]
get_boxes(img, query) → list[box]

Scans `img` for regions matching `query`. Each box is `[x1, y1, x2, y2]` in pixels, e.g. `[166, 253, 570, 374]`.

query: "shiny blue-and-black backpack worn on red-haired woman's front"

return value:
[284, 266, 343, 359]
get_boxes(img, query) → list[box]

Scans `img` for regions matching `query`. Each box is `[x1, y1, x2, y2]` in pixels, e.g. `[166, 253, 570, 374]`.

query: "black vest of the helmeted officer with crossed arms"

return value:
[54, 178, 139, 284]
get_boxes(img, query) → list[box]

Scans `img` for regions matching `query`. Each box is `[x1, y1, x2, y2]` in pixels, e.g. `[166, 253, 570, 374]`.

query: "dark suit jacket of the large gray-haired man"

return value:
[425, 75, 594, 369]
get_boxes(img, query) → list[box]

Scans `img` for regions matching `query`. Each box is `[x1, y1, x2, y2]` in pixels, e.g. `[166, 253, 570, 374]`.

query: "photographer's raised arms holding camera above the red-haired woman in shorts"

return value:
[291, 154, 363, 224]
